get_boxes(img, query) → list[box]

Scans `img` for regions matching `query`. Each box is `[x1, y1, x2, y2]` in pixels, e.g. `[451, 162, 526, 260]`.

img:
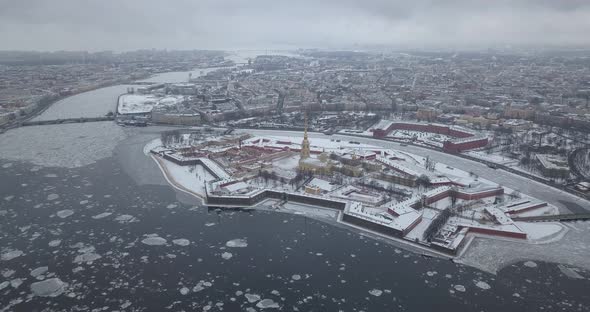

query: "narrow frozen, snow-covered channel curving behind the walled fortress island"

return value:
[236, 129, 590, 213]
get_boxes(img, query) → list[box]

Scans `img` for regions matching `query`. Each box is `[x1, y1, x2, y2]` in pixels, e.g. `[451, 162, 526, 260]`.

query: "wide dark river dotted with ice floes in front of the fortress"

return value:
[0, 56, 590, 311]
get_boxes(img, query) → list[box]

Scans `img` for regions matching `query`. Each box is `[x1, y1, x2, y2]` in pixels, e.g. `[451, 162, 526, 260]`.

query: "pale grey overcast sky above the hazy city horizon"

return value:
[0, 0, 590, 51]
